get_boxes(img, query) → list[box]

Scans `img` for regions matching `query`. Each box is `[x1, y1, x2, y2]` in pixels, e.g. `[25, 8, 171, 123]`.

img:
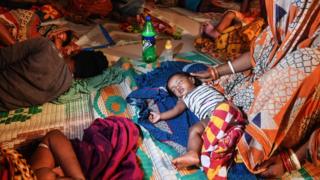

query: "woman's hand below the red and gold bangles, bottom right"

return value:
[260, 154, 286, 178]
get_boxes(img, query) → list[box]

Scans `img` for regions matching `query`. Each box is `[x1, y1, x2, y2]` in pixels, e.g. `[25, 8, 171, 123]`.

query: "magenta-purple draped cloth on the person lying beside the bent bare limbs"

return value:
[72, 117, 143, 180]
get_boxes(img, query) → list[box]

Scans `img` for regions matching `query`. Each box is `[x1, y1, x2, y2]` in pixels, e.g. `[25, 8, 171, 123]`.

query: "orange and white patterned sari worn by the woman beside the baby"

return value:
[235, 0, 320, 173]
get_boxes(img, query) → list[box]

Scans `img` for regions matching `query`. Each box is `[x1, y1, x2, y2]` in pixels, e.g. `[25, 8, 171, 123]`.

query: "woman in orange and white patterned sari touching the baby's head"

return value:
[194, 0, 320, 177]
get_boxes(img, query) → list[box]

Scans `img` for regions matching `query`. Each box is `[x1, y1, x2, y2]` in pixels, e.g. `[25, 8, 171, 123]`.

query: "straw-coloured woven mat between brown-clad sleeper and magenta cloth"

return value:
[0, 95, 93, 148]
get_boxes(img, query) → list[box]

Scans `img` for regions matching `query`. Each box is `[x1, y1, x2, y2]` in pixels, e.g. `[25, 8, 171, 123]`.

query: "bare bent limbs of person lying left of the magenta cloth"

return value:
[31, 130, 85, 179]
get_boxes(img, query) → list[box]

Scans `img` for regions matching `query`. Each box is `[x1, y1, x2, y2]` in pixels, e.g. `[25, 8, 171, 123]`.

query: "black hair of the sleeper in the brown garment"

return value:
[71, 51, 108, 78]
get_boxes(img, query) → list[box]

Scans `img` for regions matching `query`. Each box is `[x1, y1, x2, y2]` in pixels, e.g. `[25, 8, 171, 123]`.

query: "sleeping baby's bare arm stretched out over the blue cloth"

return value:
[149, 100, 187, 123]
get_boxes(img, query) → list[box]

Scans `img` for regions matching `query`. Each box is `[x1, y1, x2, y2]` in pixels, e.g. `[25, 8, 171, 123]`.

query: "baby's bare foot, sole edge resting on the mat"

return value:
[172, 151, 200, 169]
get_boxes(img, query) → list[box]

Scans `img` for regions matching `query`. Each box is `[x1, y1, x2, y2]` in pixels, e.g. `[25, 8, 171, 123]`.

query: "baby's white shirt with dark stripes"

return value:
[182, 85, 226, 120]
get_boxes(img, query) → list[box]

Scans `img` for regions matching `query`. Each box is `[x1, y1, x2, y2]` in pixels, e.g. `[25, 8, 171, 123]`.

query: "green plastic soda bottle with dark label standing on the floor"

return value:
[141, 16, 157, 63]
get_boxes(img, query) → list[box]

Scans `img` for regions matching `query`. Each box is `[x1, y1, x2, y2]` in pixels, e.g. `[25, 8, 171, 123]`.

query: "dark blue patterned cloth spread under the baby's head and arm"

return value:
[127, 61, 207, 147]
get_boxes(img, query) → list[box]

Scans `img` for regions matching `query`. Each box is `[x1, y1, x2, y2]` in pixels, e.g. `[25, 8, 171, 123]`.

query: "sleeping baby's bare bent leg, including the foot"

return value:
[172, 121, 206, 169]
